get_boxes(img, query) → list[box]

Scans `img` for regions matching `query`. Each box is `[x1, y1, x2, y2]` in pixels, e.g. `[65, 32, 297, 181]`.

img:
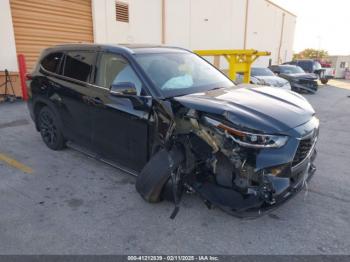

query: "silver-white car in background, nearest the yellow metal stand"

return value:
[250, 67, 291, 90]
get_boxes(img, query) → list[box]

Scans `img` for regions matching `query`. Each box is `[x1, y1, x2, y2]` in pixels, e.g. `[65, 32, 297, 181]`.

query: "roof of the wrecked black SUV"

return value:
[48, 43, 188, 54]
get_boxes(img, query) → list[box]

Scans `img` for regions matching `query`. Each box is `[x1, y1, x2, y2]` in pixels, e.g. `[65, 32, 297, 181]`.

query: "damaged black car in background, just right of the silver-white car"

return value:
[269, 65, 318, 93]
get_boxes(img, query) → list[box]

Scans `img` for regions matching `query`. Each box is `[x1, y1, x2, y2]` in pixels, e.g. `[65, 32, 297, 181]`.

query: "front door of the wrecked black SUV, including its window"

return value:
[93, 52, 151, 171]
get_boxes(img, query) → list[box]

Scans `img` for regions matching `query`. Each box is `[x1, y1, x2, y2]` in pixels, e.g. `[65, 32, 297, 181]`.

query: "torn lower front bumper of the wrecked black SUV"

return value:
[193, 141, 317, 218]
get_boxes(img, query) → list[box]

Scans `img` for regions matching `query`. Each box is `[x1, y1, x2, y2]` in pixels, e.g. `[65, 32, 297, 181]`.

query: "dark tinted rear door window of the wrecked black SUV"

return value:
[63, 51, 96, 82]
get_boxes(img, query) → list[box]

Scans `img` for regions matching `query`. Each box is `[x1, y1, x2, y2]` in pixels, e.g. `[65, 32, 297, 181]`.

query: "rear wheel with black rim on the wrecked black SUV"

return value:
[38, 107, 65, 150]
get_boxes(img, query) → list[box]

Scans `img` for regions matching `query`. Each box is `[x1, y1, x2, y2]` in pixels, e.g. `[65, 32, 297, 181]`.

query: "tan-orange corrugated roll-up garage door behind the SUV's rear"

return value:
[10, 0, 93, 70]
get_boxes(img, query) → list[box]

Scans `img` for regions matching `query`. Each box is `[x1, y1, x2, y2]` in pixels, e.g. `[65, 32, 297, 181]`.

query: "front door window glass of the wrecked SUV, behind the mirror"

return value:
[96, 53, 142, 95]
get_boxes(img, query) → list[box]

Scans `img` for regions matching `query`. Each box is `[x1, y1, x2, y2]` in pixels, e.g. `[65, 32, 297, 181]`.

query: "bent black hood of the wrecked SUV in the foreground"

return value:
[173, 85, 315, 134]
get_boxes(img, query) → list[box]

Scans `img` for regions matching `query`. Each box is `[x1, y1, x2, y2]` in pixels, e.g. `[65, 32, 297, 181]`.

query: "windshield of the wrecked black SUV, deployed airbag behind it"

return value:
[135, 52, 234, 97]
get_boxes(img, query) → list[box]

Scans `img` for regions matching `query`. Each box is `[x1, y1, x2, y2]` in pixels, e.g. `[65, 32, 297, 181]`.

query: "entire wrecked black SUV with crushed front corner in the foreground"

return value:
[28, 44, 319, 218]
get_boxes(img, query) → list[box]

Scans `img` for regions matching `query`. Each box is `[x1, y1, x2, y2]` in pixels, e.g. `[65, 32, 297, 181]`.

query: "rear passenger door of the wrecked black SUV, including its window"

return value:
[55, 51, 96, 148]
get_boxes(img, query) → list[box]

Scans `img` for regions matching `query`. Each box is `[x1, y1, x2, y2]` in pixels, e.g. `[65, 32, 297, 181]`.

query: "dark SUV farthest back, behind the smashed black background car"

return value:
[284, 59, 335, 85]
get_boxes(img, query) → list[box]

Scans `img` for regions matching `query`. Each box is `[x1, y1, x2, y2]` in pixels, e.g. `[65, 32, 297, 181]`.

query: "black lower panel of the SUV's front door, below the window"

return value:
[91, 84, 149, 171]
